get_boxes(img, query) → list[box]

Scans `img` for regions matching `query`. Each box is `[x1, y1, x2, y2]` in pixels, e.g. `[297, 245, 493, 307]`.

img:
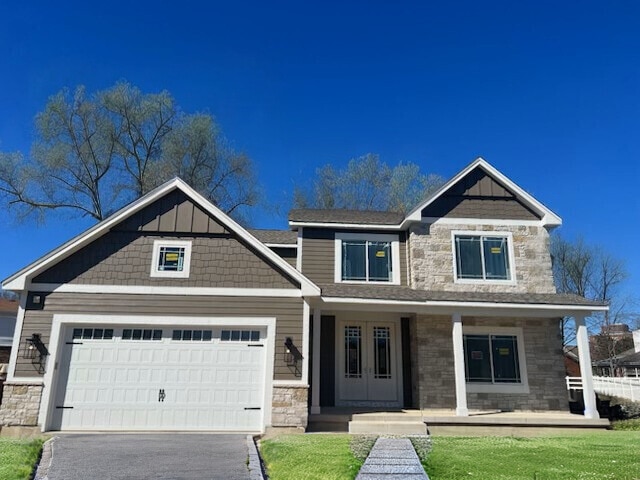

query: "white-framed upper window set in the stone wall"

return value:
[451, 231, 515, 284]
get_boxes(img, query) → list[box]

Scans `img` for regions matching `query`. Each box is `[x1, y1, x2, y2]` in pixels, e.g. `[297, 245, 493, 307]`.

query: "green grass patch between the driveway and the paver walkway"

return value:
[260, 434, 370, 480]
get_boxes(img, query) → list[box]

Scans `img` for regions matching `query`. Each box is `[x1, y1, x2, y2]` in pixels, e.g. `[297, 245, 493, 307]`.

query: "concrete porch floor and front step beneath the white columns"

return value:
[308, 407, 610, 436]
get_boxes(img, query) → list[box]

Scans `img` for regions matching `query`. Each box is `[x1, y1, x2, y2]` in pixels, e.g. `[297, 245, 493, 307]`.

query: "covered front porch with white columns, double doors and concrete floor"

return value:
[308, 301, 609, 435]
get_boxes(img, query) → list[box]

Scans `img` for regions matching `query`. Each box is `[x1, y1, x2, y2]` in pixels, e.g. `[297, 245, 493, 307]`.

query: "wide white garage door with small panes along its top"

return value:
[51, 326, 266, 431]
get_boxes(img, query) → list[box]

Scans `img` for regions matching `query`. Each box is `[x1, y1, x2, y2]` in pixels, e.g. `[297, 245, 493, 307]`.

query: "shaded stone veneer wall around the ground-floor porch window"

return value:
[412, 315, 568, 411]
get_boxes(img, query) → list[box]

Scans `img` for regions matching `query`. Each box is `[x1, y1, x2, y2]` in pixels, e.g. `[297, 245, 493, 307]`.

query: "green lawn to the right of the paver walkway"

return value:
[423, 431, 640, 480]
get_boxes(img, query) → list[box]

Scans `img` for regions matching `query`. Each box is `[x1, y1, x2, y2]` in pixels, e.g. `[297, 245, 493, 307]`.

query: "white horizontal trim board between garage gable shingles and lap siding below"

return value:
[31, 283, 302, 297]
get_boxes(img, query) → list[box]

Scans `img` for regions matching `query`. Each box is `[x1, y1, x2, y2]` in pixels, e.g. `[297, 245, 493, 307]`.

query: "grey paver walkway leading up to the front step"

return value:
[356, 438, 429, 480]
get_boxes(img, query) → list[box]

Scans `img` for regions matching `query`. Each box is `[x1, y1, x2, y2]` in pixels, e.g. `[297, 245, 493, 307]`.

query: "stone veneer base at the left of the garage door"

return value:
[0, 383, 42, 427]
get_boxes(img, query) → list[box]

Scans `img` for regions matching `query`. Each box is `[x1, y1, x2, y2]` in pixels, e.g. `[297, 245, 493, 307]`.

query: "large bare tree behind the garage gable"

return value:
[0, 82, 259, 220]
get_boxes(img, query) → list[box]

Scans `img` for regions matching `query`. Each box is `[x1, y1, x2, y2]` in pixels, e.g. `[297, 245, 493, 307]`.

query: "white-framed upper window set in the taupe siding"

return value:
[335, 233, 400, 285]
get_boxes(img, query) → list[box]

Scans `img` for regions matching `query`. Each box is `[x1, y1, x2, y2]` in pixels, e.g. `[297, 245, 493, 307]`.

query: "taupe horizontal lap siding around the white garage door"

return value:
[15, 292, 303, 381]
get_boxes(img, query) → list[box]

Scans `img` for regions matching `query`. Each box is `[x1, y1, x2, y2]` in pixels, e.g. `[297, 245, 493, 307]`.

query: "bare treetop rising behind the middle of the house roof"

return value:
[294, 153, 443, 213]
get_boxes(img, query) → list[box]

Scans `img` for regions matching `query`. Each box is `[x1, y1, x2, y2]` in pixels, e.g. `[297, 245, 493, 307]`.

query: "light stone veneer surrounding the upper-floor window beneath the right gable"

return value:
[409, 223, 556, 293]
